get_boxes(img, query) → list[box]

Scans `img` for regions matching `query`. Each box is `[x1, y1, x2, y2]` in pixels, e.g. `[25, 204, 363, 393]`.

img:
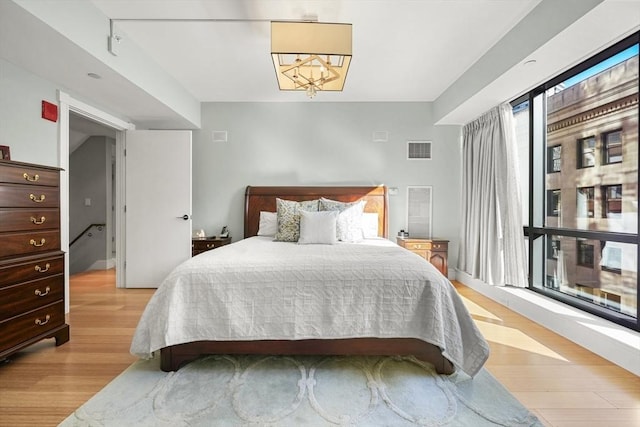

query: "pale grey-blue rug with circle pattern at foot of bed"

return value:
[60, 356, 542, 427]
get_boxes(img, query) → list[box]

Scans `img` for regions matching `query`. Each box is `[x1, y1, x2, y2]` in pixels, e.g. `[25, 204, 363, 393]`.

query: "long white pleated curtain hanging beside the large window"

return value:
[458, 104, 527, 287]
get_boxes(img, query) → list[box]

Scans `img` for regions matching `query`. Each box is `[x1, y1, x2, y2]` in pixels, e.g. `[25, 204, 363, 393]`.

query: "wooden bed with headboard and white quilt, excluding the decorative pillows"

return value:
[131, 186, 489, 376]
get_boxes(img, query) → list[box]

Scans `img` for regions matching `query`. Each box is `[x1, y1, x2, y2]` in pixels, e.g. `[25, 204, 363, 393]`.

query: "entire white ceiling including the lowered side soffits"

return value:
[0, 0, 640, 129]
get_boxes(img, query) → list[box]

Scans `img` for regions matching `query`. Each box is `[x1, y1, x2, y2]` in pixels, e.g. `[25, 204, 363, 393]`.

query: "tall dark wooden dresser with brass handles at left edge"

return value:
[0, 160, 69, 360]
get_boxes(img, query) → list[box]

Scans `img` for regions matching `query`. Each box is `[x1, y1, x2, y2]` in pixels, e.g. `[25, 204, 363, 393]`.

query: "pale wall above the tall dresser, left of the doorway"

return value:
[0, 59, 59, 166]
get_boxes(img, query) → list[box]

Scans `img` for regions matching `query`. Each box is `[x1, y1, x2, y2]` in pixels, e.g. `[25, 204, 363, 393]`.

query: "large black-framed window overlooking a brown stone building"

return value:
[512, 33, 640, 330]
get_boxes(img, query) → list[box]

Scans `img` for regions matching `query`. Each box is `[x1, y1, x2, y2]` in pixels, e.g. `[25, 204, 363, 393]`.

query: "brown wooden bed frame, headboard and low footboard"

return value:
[160, 186, 454, 374]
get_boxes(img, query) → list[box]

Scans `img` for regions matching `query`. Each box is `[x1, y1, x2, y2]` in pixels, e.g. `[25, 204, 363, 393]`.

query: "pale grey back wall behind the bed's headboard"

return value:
[193, 102, 460, 272]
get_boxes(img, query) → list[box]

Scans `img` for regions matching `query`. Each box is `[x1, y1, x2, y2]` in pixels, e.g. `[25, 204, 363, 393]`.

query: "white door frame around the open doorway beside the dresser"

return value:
[58, 90, 135, 313]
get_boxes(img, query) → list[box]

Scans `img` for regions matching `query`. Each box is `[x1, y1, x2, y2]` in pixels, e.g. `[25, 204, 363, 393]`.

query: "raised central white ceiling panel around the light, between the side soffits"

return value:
[91, 0, 540, 102]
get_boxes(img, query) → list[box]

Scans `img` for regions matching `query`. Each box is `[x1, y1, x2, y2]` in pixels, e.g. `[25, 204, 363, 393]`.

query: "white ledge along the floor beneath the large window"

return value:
[456, 270, 640, 376]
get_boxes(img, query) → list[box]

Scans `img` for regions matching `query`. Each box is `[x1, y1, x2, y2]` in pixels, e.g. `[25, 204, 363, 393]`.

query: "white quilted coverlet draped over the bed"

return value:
[131, 237, 489, 375]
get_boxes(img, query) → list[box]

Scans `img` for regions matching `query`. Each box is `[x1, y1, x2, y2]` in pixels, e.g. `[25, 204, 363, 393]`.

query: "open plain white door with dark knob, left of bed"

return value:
[124, 130, 191, 288]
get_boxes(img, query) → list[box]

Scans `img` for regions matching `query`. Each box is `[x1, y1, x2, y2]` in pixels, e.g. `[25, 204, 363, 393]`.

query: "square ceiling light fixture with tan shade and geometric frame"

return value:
[271, 21, 352, 98]
